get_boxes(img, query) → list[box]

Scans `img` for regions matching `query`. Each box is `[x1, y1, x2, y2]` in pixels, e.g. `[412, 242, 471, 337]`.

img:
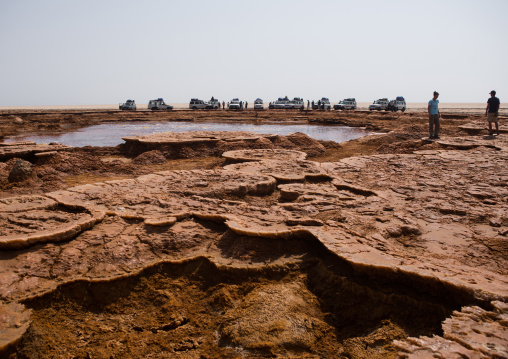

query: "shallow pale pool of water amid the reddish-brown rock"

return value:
[5, 122, 367, 147]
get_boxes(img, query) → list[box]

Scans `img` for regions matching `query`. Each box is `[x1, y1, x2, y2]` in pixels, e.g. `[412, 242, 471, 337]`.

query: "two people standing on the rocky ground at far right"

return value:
[427, 90, 501, 139]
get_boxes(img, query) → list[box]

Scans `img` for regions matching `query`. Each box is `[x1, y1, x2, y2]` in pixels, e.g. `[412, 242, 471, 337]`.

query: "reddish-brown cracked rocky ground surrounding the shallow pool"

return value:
[0, 111, 508, 358]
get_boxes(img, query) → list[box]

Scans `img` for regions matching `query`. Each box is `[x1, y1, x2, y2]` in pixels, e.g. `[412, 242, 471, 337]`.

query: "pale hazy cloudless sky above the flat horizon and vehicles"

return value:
[0, 0, 508, 106]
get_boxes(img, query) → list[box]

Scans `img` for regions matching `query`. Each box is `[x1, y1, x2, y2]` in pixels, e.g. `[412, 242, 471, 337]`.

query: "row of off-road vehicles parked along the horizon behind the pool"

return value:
[119, 96, 406, 112]
